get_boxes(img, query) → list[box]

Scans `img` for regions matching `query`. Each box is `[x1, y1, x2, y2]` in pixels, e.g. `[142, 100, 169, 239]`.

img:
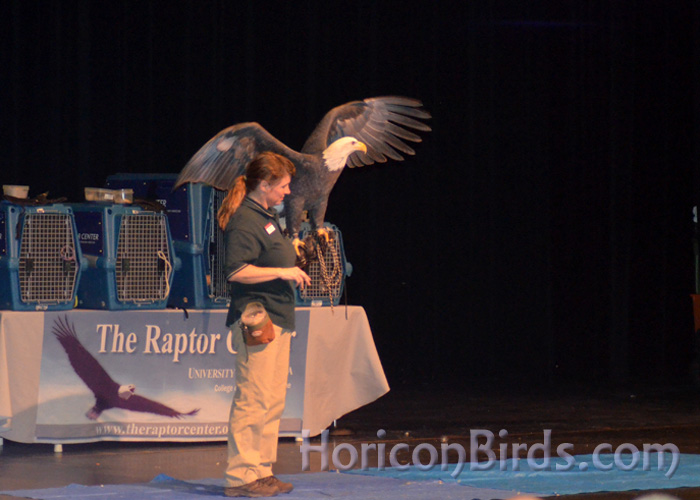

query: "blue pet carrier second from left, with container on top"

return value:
[73, 203, 179, 310]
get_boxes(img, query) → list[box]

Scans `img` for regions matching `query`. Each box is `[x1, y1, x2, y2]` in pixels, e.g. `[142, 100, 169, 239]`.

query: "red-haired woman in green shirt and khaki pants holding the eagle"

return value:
[219, 153, 311, 497]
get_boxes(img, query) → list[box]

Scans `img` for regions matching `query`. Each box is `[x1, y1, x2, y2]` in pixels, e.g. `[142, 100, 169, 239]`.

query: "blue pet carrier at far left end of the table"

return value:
[0, 201, 85, 311]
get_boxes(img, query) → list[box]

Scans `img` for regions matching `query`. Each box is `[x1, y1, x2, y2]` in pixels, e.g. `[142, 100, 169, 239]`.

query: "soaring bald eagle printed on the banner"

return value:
[51, 318, 199, 420]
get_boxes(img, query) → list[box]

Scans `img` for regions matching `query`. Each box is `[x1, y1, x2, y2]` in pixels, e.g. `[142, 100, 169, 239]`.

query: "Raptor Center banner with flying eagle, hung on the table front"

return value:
[36, 310, 309, 443]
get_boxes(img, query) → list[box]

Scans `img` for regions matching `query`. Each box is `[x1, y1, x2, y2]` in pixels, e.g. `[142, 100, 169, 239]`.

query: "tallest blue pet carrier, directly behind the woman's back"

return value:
[106, 174, 231, 309]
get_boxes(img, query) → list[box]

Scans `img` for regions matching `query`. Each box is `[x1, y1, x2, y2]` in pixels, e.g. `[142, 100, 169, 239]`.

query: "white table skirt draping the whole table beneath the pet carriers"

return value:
[0, 306, 389, 443]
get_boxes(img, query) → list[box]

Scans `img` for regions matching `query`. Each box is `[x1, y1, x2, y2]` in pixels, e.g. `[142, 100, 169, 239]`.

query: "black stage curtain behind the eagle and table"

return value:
[0, 0, 700, 386]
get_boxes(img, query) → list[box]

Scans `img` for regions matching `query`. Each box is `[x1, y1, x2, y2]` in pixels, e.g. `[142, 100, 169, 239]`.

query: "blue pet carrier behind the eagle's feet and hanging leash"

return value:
[296, 222, 352, 306]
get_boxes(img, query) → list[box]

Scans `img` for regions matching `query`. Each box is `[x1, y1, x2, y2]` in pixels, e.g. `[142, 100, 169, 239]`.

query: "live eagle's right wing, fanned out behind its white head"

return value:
[301, 96, 431, 167]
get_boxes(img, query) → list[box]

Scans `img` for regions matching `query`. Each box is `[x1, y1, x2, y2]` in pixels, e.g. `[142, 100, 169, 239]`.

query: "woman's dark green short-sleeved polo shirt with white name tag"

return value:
[225, 196, 296, 330]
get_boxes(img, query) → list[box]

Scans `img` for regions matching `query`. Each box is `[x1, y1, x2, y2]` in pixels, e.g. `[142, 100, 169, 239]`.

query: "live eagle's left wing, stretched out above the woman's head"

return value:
[175, 122, 300, 191]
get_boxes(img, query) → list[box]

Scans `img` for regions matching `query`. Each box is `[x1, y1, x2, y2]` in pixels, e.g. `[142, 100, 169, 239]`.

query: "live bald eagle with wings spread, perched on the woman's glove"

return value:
[175, 96, 430, 238]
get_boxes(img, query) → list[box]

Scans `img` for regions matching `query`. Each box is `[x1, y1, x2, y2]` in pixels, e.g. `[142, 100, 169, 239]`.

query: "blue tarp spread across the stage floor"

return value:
[0, 454, 700, 500]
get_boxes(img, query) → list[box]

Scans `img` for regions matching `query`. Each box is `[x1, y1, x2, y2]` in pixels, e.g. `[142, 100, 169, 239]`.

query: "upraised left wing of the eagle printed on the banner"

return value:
[51, 318, 119, 397]
